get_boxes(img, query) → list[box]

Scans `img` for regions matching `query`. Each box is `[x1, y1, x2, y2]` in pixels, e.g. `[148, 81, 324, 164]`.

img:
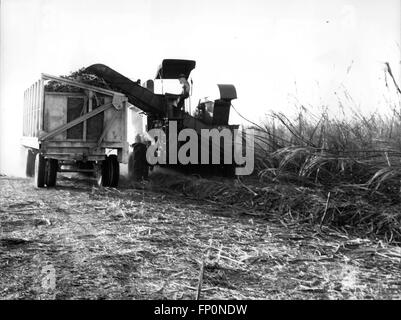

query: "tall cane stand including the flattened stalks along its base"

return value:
[241, 69, 401, 240]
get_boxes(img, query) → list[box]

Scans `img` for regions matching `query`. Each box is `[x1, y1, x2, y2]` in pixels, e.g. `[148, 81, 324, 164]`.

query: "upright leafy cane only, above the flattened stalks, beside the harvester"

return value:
[254, 80, 401, 195]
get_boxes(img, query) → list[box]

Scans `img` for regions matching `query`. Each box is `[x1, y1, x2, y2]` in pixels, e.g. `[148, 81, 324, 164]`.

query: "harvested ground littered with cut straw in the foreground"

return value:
[0, 176, 401, 299]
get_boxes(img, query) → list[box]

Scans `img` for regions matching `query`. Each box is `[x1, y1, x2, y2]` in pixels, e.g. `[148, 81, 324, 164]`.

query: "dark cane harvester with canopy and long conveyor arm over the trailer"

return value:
[85, 59, 238, 177]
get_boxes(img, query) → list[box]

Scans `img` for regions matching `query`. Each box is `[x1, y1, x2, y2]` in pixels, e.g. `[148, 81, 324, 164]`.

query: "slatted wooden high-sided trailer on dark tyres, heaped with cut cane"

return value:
[21, 74, 129, 188]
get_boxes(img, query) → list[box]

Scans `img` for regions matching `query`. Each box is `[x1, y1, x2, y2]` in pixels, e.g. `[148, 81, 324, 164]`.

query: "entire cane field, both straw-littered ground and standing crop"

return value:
[0, 64, 401, 299]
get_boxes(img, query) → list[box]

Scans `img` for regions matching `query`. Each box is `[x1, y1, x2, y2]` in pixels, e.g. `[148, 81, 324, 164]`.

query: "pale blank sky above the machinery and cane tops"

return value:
[0, 0, 401, 173]
